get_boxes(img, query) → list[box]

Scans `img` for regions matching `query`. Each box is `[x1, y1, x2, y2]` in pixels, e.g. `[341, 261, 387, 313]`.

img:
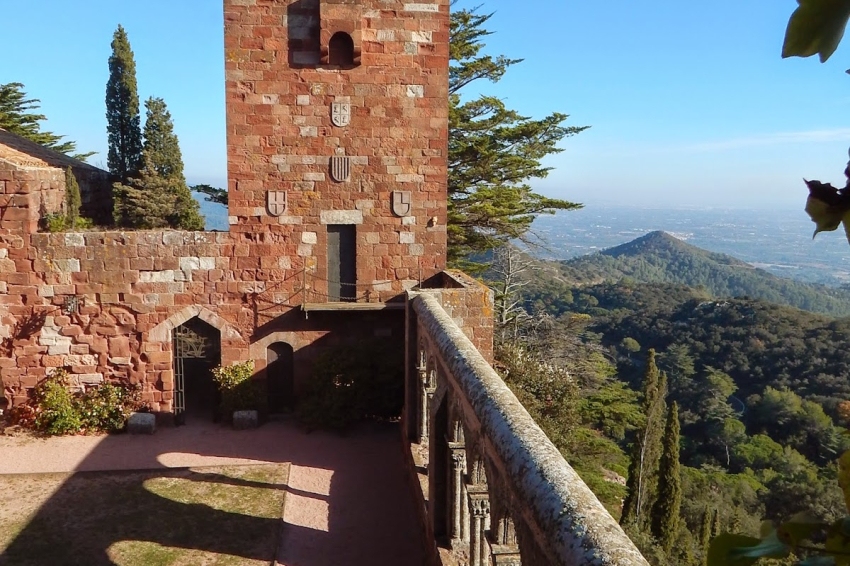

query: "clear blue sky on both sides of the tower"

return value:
[0, 0, 850, 208]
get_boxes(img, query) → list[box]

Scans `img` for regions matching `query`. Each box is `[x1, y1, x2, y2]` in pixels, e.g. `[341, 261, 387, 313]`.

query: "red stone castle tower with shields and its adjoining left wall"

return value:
[0, 0, 454, 420]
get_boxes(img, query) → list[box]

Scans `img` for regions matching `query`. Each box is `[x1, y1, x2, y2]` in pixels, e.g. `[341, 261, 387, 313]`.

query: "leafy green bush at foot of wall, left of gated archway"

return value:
[10, 369, 142, 435]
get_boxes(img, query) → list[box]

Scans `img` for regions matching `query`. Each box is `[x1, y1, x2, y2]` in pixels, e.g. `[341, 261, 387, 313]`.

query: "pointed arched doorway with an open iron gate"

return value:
[172, 317, 221, 424]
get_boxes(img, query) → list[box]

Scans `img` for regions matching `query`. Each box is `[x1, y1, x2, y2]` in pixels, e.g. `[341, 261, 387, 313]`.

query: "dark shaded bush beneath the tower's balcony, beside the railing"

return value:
[297, 340, 404, 430]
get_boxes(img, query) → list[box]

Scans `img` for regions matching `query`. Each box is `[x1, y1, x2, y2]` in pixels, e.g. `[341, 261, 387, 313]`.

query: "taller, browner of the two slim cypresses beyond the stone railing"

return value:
[620, 349, 667, 527]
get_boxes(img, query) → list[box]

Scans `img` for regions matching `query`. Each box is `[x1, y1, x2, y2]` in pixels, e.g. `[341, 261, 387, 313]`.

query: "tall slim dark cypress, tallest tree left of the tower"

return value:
[106, 25, 142, 182]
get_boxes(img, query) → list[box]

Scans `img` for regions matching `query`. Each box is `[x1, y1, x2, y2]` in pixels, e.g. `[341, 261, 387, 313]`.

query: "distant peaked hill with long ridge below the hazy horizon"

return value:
[548, 232, 850, 317]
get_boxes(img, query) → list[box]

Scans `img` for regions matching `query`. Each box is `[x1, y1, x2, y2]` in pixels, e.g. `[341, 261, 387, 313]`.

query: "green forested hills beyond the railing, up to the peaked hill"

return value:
[490, 245, 850, 566]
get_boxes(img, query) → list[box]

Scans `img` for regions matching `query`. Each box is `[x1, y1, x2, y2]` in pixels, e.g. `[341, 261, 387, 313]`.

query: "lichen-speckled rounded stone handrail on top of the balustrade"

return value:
[411, 291, 648, 566]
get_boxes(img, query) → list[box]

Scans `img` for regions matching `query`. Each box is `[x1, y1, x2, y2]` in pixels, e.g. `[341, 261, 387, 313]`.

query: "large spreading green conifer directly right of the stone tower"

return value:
[448, 10, 585, 265]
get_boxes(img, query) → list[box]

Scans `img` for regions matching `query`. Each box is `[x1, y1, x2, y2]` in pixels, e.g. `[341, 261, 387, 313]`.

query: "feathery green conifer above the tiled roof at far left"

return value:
[0, 83, 94, 160]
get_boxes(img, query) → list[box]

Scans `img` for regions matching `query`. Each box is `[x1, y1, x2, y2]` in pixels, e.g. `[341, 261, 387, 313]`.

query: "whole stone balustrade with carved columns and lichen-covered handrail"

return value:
[405, 291, 648, 566]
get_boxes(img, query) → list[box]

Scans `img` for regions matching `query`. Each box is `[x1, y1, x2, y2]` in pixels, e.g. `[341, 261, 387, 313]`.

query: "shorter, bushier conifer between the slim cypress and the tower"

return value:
[113, 98, 204, 230]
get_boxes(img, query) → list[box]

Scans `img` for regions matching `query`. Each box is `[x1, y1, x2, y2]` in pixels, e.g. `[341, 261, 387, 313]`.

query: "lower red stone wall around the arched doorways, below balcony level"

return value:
[0, 231, 404, 412]
